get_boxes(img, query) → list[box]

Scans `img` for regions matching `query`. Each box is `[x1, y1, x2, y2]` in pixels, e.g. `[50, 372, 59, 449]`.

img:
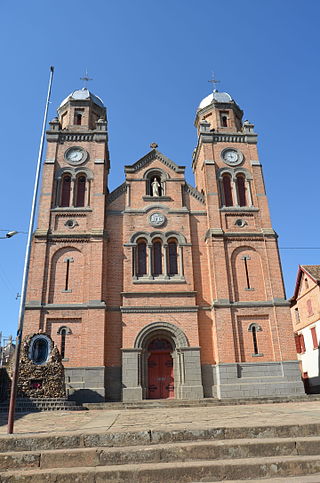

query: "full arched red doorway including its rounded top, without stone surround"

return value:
[147, 337, 174, 399]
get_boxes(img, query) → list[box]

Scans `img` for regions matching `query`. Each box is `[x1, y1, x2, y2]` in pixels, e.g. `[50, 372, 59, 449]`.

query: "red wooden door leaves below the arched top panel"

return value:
[148, 351, 174, 399]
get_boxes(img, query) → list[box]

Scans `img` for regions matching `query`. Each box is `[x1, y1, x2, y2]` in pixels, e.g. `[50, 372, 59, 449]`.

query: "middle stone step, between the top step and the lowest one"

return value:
[0, 437, 320, 471]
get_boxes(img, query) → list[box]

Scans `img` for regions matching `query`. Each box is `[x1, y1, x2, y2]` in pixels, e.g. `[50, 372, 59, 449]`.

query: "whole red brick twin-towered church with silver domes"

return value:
[25, 89, 303, 401]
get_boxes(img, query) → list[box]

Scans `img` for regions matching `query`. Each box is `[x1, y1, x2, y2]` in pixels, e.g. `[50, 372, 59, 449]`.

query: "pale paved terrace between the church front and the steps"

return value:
[0, 401, 320, 435]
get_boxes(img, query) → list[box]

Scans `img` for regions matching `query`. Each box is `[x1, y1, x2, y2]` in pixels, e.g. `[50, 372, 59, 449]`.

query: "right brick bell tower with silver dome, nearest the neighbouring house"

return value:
[192, 91, 303, 398]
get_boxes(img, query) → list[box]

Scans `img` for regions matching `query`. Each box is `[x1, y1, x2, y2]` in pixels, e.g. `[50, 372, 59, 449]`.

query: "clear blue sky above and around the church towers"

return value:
[0, 0, 320, 335]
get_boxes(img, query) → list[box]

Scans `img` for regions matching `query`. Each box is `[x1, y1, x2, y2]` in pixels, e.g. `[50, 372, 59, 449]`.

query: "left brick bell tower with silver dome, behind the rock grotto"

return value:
[24, 88, 109, 401]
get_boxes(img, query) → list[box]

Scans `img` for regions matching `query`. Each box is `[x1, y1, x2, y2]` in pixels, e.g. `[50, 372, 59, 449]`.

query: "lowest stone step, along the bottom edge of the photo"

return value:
[1, 456, 320, 483]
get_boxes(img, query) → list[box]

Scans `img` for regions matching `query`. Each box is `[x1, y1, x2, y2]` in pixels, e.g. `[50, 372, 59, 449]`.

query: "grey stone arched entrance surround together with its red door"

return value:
[122, 322, 203, 402]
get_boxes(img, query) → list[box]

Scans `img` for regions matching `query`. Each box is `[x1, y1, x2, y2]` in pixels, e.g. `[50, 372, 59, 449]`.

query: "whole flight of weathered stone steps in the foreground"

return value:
[0, 424, 320, 483]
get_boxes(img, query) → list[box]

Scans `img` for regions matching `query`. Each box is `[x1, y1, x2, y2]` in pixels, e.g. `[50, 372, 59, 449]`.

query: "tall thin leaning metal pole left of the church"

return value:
[7, 66, 54, 434]
